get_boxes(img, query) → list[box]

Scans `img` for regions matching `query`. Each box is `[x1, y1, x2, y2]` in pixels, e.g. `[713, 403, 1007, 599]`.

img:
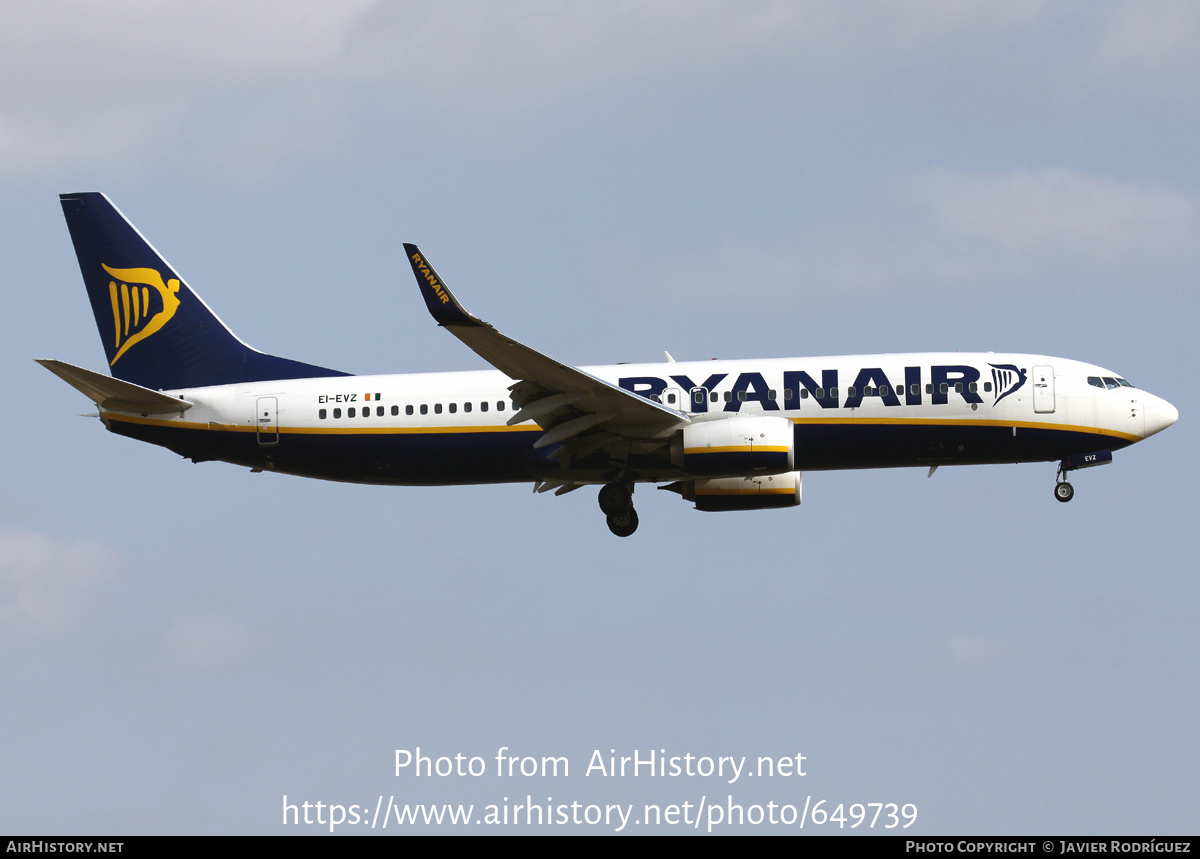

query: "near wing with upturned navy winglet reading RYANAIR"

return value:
[404, 244, 690, 450]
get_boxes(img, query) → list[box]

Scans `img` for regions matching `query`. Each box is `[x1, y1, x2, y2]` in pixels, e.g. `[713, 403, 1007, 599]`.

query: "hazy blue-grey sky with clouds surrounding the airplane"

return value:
[0, 0, 1200, 835]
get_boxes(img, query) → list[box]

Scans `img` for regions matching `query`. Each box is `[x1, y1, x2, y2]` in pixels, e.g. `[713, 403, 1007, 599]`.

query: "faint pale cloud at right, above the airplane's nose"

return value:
[624, 168, 1200, 305]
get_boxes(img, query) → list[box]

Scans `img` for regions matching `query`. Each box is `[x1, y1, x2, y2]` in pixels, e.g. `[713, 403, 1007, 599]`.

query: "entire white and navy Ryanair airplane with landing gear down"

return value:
[40, 192, 1178, 536]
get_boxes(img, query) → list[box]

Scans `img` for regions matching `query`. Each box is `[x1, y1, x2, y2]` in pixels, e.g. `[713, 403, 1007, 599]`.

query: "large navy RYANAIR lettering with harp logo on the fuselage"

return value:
[618, 364, 1027, 413]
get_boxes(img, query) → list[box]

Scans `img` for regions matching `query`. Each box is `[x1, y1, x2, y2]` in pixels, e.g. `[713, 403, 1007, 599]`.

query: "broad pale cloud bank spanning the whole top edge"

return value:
[0, 0, 1200, 175]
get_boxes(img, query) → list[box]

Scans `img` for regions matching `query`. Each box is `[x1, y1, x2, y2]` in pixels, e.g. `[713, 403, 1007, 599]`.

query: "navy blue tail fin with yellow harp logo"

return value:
[59, 192, 348, 390]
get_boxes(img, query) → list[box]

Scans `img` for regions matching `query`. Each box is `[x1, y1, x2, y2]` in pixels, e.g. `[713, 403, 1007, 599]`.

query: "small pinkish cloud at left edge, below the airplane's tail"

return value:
[0, 528, 116, 638]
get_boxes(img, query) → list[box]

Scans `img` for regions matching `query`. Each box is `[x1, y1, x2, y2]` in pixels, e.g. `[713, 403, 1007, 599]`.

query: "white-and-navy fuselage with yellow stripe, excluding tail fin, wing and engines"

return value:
[104, 353, 1177, 483]
